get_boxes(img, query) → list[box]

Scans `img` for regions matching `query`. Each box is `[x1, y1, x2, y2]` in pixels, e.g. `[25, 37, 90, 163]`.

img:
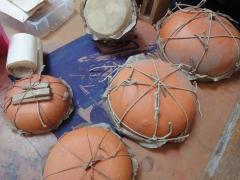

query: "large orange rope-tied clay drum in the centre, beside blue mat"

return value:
[104, 59, 197, 148]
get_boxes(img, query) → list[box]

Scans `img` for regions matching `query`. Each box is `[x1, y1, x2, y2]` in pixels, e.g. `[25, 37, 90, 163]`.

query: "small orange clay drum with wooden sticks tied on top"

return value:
[4, 75, 73, 134]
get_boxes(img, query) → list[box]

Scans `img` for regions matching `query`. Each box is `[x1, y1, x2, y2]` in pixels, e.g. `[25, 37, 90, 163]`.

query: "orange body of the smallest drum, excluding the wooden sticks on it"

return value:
[4, 75, 73, 134]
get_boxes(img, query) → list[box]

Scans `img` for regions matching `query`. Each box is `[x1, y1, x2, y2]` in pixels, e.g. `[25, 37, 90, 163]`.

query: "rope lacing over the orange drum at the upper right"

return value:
[157, 0, 240, 80]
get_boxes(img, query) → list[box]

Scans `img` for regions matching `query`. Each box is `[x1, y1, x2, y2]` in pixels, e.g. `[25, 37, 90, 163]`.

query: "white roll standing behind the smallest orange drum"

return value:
[6, 33, 43, 78]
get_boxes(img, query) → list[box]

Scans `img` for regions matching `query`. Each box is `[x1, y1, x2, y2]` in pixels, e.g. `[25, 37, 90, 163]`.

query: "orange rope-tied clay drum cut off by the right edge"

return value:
[158, 7, 240, 81]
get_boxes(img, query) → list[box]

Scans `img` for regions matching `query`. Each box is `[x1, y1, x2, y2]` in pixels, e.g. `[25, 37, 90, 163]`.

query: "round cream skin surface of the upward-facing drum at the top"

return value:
[84, 0, 131, 35]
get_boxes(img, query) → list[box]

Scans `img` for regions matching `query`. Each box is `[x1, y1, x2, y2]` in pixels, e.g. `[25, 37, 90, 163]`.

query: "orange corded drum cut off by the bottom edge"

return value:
[43, 127, 133, 180]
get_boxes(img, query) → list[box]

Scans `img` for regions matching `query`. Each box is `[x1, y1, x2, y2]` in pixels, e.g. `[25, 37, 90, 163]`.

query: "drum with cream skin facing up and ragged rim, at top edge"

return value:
[82, 0, 137, 40]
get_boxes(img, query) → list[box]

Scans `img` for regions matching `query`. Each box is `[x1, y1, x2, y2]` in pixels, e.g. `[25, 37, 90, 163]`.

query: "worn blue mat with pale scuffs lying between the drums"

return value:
[44, 35, 156, 137]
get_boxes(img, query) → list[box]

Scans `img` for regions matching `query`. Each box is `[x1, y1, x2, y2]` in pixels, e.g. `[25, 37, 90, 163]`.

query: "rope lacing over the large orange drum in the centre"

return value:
[104, 59, 201, 144]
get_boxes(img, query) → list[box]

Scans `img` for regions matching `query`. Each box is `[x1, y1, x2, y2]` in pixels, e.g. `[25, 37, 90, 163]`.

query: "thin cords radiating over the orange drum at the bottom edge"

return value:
[43, 127, 132, 180]
